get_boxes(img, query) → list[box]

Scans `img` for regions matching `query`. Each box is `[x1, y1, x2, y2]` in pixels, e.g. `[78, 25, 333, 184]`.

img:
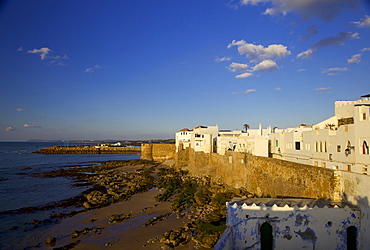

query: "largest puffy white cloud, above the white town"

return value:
[227, 40, 291, 62]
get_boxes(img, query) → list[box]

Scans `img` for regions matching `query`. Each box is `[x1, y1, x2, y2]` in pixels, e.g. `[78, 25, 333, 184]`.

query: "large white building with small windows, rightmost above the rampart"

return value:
[269, 95, 370, 174]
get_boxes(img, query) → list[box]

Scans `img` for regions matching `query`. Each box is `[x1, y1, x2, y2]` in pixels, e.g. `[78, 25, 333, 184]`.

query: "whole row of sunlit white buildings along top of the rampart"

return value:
[176, 95, 370, 174]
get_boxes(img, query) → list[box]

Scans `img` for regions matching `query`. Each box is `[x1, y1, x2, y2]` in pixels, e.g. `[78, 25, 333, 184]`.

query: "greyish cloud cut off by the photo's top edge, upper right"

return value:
[241, 0, 358, 22]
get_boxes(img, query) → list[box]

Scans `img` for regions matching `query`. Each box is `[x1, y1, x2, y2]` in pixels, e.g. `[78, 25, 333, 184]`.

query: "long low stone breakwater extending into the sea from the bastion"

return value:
[33, 146, 141, 154]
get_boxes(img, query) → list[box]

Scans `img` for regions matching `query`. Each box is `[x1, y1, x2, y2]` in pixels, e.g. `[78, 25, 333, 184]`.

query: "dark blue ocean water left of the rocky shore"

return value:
[0, 142, 140, 249]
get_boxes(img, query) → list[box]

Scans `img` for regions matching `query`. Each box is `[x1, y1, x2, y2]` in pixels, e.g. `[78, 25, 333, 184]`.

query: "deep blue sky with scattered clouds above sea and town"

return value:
[0, 0, 370, 141]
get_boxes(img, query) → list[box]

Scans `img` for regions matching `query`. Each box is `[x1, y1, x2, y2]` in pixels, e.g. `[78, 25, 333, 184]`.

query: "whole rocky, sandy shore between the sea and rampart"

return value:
[13, 160, 252, 249]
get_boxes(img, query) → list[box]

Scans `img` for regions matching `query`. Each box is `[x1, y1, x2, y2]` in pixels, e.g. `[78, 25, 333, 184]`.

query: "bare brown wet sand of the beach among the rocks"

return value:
[20, 161, 212, 249]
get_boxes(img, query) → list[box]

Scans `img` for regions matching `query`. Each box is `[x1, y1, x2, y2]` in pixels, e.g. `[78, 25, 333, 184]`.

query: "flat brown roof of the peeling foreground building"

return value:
[229, 197, 359, 210]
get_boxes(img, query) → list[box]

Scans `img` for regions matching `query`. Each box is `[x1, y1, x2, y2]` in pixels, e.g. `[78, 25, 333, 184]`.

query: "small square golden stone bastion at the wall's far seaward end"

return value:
[141, 144, 176, 161]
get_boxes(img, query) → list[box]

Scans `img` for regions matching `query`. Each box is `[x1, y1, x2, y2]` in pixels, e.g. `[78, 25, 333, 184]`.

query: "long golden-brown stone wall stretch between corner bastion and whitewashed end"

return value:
[176, 148, 340, 200]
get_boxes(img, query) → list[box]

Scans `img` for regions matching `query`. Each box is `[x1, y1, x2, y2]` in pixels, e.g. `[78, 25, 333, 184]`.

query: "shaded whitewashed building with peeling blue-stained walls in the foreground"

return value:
[214, 198, 362, 250]
